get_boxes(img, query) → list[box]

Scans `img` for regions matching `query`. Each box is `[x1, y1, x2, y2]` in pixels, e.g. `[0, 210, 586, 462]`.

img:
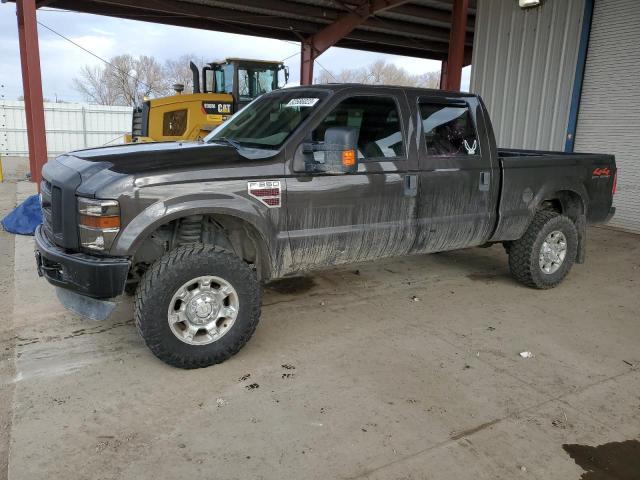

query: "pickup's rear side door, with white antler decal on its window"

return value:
[411, 96, 499, 253]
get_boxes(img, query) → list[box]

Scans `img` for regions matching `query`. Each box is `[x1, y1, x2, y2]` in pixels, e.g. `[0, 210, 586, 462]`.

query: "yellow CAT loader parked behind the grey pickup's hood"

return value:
[125, 58, 289, 143]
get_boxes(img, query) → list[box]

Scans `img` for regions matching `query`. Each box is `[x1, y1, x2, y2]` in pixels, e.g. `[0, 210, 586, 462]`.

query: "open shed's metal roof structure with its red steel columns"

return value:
[13, 0, 477, 183]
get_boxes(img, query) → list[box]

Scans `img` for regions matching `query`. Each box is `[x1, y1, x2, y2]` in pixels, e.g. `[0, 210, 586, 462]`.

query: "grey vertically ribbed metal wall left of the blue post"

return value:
[471, 0, 584, 150]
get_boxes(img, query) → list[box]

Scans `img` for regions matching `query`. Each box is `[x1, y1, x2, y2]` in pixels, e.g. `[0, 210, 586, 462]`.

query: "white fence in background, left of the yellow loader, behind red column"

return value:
[0, 101, 131, 156]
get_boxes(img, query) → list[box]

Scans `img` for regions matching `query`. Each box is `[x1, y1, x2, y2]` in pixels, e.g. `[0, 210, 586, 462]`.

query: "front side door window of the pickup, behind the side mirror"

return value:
[312, 96, 405, 160]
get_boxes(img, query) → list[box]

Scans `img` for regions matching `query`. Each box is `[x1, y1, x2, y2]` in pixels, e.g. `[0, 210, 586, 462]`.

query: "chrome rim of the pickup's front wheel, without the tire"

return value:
[167, 276, 240, 345]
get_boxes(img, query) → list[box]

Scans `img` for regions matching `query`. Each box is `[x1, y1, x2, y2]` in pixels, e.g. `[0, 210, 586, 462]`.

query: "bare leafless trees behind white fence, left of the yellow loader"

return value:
[74, 55, 170, 106]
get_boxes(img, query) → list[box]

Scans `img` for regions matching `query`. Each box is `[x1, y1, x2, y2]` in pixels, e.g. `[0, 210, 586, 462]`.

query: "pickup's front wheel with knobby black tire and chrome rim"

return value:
[135, 244, 260, 368]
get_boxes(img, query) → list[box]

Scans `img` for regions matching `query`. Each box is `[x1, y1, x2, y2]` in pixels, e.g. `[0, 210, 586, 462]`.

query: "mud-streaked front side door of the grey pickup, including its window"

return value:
[286, 89, 415, 270]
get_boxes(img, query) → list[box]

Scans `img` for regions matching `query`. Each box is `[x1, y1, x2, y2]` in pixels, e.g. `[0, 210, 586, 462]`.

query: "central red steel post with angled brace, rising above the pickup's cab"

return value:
[300, 0, 410, 85]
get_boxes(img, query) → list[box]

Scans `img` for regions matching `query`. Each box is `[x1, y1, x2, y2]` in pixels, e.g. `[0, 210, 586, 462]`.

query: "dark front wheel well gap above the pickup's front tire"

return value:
[129, 214, 269, 283]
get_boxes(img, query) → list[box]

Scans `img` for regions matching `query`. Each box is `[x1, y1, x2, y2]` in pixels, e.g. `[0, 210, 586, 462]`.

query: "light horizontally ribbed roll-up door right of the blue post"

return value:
[575, 0, 640, 233]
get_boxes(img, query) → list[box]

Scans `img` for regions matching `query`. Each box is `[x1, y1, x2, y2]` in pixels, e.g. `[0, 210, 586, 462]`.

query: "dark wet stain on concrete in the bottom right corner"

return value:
[562, 440, 640, 480]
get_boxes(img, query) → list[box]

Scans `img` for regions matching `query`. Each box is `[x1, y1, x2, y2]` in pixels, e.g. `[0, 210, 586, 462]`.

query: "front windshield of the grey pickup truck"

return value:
[204, 90, 327, 149]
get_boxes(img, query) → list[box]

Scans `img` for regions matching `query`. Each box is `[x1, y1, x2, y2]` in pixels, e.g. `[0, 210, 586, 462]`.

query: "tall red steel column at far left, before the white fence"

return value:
[16, 0, 47, 190]
